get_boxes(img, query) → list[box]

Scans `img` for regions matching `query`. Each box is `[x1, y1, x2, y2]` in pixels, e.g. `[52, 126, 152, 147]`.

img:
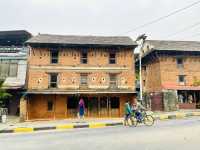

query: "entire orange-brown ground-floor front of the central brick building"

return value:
[26, 93, 135, 120]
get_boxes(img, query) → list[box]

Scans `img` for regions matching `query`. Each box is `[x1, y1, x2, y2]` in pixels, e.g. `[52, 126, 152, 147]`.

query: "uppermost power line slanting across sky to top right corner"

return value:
[120, 1, 200, 34]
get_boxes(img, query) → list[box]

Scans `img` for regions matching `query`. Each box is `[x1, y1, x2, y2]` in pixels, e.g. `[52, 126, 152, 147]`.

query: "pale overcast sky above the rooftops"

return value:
[0, 0, 200, 41]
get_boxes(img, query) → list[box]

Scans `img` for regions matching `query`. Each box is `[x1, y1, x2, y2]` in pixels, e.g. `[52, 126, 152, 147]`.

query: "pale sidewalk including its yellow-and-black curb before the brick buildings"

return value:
[0, 110, 200, 133]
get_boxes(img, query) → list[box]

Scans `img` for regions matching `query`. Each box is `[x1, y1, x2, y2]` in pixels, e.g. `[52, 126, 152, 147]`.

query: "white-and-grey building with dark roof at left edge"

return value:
[0, 30, 31, 115]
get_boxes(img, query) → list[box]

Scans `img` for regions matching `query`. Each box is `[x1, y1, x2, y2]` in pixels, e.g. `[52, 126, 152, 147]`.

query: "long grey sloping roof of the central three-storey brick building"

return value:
[26, 34, 137, 46]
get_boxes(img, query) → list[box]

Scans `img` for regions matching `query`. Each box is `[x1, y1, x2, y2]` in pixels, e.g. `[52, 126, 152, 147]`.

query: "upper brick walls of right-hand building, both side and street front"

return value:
[142, 56, 200, 92]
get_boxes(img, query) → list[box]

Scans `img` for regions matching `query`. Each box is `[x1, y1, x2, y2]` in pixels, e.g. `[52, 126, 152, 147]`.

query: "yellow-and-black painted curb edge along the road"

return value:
[0, 112, 200, 134]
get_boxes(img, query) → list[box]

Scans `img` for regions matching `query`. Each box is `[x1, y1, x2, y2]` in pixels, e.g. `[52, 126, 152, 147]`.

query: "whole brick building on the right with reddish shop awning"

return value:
[142, 40, 200, 111]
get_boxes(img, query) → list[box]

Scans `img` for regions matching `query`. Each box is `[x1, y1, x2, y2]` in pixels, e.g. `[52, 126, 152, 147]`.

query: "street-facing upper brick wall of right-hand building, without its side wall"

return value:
[160, 56, 200, 86]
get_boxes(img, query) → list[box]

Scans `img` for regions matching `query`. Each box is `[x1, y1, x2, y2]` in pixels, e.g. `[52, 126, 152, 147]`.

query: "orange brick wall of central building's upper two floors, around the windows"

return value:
[28, 48, 135, 89]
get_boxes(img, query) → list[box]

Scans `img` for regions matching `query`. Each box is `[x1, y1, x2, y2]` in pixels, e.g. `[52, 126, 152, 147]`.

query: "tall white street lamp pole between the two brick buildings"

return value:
[136, 34, 147, 101]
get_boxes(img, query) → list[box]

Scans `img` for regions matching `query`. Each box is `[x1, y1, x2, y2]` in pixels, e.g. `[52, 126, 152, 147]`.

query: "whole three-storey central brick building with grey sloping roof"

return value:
[21, 34, 136, 119]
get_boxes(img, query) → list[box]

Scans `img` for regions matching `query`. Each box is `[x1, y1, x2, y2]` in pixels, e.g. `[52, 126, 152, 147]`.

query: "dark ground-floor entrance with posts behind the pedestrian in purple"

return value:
[67, 96, 120, 117]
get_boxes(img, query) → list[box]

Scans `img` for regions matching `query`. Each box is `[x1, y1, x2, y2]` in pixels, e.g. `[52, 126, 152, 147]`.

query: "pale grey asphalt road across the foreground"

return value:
[0, 117, 200, 150]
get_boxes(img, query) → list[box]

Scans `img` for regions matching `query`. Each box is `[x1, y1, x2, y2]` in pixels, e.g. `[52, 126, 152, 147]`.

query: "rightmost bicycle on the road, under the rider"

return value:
[131, 110, 155, 127]
